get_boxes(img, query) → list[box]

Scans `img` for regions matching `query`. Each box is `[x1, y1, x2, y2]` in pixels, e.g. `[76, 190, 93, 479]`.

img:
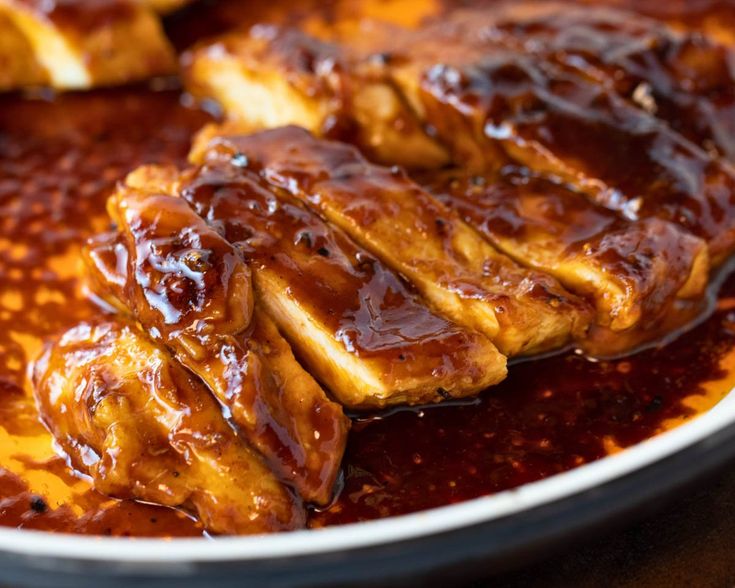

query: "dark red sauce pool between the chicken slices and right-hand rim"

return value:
[313, 280, 735, 525]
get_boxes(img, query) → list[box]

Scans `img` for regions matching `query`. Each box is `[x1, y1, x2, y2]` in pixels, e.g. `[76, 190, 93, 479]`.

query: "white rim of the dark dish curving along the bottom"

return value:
[0, 388, 735, 565]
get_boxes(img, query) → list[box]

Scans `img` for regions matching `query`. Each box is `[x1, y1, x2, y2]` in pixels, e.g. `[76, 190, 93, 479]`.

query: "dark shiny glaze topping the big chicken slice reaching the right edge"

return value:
[414, 49, 735, 262]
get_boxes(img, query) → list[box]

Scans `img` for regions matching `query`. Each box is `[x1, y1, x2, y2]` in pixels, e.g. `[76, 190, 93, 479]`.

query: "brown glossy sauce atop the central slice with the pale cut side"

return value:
[183, 165, 462, 361]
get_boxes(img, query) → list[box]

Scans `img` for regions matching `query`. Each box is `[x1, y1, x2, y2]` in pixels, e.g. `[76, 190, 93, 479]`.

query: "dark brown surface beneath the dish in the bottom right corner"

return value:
[474, 463, 735, 588]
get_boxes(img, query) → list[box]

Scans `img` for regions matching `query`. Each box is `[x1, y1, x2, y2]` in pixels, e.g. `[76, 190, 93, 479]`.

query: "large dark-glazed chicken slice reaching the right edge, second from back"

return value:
[185, 20, 735, 264]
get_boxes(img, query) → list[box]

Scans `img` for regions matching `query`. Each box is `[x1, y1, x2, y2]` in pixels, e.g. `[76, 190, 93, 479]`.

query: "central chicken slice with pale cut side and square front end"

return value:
[172, 158, 506, 408]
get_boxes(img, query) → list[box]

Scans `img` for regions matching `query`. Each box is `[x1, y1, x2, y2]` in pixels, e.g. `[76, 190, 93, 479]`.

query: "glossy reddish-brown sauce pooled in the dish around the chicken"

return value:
[0, 0, 735, 537]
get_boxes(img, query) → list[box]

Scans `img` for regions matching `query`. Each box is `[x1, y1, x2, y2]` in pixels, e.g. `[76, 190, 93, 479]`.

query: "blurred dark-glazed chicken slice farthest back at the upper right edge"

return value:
[442, 2, 735, 160]
